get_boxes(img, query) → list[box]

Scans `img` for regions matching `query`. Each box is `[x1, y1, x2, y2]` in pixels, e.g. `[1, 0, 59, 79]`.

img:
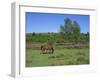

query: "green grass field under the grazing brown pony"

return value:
[26, 48, 89, 67]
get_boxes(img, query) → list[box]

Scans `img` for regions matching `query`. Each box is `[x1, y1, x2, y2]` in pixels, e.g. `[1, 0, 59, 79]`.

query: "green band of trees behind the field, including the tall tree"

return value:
[26, 18, 89, 44]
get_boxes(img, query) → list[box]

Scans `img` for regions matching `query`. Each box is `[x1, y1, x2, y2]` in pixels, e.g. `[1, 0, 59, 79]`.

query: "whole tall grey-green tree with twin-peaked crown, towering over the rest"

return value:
[60, 18, 80, 43]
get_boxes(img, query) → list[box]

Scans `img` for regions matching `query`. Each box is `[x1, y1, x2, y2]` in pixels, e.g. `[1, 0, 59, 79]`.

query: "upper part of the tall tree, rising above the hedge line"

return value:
[60, 18, 80, 35]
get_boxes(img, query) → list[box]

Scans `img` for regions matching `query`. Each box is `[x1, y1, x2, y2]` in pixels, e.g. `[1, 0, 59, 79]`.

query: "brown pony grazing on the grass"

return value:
[41, 43, 54, 54]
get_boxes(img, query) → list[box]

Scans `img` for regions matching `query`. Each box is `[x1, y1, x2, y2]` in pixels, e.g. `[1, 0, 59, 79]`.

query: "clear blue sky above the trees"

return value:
[25, 12, 89, 33]
